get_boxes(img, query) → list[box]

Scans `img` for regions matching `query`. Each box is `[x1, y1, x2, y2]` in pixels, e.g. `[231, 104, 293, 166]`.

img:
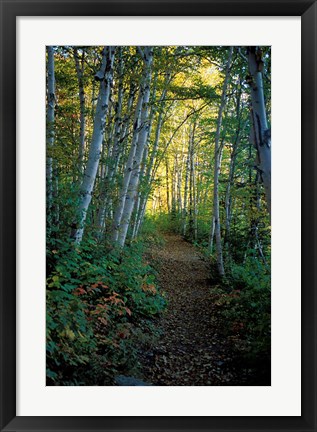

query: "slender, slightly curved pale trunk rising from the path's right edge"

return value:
[213, 47, 233, 277]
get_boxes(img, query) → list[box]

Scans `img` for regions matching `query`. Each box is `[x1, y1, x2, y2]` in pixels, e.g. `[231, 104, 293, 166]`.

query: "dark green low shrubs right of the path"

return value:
[212, 257, 271, 364]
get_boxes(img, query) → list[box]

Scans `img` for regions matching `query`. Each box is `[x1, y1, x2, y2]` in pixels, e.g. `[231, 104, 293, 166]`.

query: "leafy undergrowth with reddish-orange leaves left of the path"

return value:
[47, 236, 165, 385]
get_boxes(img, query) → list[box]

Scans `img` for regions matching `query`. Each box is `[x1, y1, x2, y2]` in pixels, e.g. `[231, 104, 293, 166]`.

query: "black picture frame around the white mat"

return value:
[0, 0, 317, 432]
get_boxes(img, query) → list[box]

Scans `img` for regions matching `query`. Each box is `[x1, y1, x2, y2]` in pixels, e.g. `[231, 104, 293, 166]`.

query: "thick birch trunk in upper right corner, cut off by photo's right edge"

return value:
[248, 47, 271, 216]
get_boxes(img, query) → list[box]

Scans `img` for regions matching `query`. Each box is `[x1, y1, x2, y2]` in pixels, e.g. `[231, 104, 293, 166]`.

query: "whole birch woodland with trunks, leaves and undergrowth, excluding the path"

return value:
[46, 46, 271, 385]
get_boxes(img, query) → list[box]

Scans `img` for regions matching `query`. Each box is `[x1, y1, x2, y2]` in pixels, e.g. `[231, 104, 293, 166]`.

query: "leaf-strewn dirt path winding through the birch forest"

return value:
[141, 234, 237, 386]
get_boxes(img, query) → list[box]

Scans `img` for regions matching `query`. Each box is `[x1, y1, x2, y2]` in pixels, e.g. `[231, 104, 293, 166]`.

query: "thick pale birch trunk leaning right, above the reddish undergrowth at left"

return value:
[72, 47, 115, 244]
